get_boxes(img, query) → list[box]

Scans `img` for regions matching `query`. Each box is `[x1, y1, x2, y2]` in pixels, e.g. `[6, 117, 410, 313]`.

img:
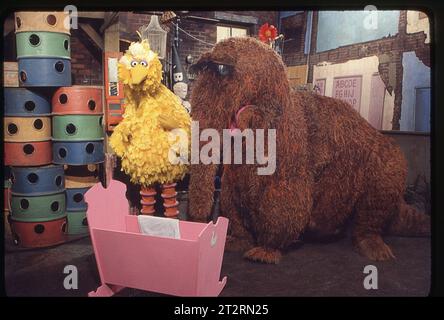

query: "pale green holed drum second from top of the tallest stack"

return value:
[15, 31, 71, 59]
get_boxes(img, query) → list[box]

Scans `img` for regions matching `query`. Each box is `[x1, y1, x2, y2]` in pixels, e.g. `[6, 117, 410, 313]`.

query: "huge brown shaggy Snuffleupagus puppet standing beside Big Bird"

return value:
[189, 38, 430, 263]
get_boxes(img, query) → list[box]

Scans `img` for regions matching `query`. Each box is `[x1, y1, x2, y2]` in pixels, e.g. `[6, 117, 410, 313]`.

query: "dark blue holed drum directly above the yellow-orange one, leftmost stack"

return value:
[3, 88, 51, 117]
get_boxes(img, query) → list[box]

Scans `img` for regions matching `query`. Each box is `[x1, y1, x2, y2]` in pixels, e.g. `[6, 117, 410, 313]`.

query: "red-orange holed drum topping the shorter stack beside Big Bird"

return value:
[52, 86, 103, 115]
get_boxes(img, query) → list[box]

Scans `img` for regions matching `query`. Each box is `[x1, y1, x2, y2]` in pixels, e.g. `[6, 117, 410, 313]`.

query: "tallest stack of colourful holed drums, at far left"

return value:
[4, 12, 71, 247]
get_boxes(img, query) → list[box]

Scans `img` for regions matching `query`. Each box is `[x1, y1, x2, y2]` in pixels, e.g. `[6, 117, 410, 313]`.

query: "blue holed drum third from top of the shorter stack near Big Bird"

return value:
[52, 141, 105, 165]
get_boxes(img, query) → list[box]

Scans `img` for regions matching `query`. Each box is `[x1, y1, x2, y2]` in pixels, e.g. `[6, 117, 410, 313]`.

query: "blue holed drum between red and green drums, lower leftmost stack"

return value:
[11, 165, 65, 196]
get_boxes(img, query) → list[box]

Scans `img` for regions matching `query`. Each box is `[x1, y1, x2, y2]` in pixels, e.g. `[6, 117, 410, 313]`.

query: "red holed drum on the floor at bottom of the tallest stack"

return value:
[10, 217, 67, 248]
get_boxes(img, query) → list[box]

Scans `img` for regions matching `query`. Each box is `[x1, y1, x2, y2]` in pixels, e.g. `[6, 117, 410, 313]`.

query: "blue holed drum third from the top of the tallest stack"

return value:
[18, 58, 71, 87]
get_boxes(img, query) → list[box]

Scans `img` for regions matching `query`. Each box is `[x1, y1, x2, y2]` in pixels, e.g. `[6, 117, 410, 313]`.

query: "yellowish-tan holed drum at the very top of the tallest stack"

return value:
[15, 11, 70, 34]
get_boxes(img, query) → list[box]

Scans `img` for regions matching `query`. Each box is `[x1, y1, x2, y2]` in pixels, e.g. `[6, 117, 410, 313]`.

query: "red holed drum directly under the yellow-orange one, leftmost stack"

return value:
[5, 141, 52, 167]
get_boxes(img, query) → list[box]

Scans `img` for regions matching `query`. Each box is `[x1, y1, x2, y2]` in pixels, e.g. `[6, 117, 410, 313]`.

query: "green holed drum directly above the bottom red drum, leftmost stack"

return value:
[11, 192, 66, 222]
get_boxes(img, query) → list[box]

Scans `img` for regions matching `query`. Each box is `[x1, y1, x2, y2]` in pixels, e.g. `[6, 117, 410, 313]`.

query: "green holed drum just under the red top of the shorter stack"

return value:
[52, 115, 104, 141]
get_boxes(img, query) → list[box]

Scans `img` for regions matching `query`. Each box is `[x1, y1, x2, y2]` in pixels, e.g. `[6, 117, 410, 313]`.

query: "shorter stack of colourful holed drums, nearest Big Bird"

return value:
[52, 86, 105, 234]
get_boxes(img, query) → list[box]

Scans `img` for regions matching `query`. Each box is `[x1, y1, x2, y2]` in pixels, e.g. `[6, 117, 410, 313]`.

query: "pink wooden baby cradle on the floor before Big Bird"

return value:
[85, 180, 228, 296]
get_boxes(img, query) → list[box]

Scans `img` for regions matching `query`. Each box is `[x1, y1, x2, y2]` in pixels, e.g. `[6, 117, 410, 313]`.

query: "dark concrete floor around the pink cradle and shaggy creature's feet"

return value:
[5, 237, 431, 296]
